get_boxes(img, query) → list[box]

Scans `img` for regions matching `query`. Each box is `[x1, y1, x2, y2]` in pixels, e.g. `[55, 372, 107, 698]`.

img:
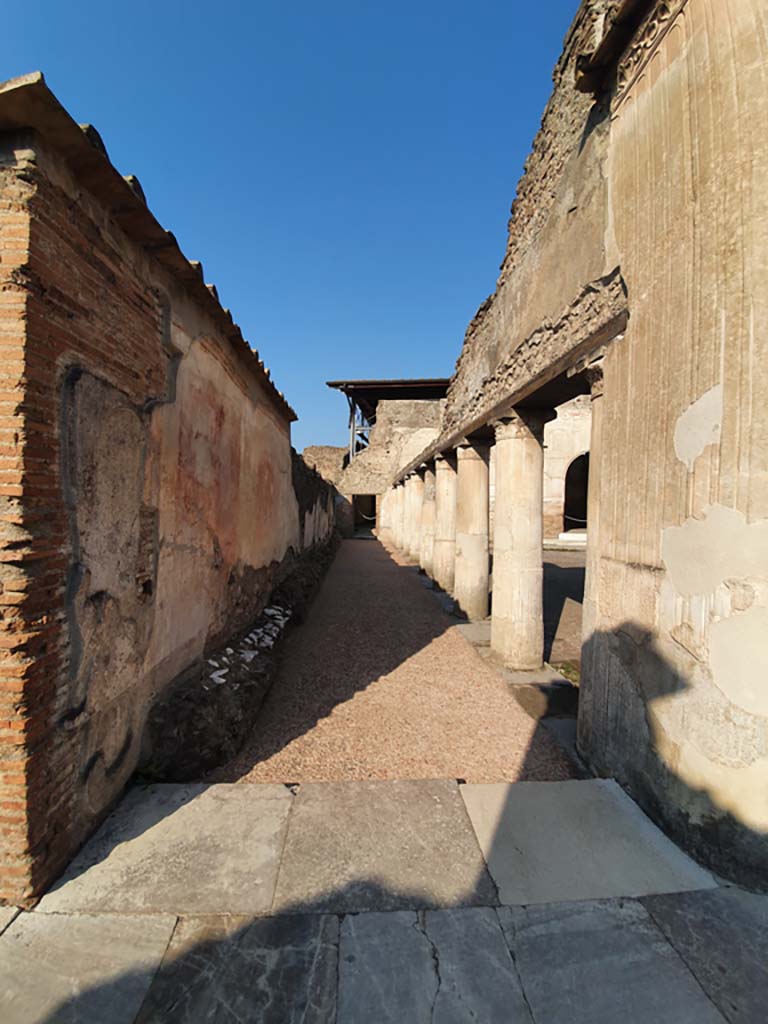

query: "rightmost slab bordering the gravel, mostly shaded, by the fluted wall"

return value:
[461, 779, 716, 904]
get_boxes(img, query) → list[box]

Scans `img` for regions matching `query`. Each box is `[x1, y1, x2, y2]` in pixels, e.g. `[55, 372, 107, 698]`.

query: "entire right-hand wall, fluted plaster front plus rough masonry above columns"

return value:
[397, 0, 768, 887]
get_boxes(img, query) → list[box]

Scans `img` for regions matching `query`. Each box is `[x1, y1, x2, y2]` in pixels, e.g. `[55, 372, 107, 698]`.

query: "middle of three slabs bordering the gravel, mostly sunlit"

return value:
[273, 779, 497, 913]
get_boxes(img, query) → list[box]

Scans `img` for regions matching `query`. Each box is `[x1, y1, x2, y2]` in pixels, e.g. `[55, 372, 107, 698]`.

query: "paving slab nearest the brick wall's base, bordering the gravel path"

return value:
[33, 784, 294, 914]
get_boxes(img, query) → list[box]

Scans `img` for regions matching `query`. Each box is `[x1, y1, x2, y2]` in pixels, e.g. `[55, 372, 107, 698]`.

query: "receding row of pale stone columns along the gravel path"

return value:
[387, 410, 555, 669]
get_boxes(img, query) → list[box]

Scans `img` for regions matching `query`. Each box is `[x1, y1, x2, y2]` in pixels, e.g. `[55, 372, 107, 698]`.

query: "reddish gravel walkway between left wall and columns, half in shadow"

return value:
[210, 541, 573, 782]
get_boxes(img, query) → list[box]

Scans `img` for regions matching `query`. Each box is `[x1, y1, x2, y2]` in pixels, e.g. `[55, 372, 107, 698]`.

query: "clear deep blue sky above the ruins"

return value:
[6, 0, 578, 451]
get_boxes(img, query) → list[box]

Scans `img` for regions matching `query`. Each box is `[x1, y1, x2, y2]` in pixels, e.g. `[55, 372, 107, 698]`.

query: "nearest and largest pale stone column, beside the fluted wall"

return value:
[490, 410, 554, 669]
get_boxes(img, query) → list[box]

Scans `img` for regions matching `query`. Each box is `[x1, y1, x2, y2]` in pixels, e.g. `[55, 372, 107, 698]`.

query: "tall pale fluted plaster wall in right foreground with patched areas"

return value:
[580, 0, 768, 886]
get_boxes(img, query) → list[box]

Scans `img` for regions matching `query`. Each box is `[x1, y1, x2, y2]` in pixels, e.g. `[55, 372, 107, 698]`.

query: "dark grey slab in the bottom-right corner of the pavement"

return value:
[642, 889, 768, 1024]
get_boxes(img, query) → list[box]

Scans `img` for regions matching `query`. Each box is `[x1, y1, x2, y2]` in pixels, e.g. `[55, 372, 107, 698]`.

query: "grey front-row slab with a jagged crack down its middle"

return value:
[338, 907, 532, 1024]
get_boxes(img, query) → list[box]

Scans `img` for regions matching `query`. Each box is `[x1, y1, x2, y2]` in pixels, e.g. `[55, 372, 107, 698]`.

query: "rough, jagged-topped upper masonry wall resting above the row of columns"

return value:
[443, 0, 626, 437]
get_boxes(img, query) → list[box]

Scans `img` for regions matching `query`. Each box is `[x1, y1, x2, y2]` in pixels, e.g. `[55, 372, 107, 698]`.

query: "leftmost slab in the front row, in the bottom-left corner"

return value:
[0, 913, 176, 1024]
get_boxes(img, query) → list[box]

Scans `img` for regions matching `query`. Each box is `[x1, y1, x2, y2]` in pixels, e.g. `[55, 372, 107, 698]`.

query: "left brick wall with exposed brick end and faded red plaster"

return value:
[0, 117, 331, 900]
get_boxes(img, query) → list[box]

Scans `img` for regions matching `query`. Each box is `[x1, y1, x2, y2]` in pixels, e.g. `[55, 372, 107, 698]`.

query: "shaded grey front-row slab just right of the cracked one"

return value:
[499, 900, 724, 1024]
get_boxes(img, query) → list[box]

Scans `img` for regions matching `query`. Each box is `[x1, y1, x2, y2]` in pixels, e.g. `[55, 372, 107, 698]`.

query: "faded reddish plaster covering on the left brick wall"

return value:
[62, 297, 305, 839]
